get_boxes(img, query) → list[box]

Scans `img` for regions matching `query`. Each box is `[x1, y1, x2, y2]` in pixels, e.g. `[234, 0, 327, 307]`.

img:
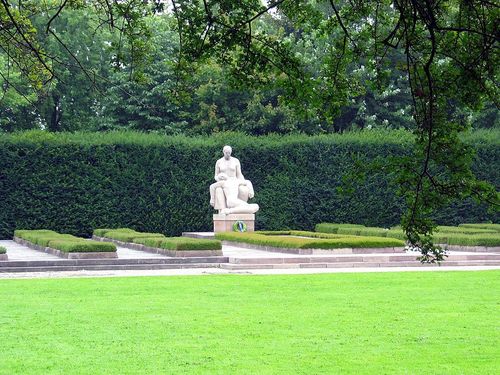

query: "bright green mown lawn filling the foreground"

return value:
[0, 271, 500, 375]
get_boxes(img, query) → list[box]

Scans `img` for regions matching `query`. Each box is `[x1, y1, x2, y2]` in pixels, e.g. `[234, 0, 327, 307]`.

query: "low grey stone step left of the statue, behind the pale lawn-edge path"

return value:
[0, 263, 219, 273]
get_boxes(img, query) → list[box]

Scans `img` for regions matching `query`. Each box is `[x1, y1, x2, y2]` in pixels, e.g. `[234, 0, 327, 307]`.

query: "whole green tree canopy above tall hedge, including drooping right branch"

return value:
[0, 0, 500, 261]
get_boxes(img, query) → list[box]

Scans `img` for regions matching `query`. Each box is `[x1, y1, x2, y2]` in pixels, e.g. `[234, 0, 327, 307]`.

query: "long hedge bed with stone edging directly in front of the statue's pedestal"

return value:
[215, 231, 405, 254]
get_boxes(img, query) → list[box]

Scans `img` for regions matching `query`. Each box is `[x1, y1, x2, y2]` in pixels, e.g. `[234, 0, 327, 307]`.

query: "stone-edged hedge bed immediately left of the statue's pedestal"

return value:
[92, 228, 222, 257]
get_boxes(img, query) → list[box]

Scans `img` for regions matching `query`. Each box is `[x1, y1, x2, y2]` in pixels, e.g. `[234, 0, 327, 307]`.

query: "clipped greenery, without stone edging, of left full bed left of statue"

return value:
[14, 229, 116, 253]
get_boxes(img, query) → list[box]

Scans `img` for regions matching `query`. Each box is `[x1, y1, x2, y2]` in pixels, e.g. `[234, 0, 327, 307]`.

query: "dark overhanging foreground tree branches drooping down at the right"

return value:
[173, 0, 499, 261]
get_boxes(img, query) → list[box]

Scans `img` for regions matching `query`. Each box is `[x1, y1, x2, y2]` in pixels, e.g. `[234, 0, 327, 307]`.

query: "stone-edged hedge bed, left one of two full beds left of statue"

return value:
[14, 229, 117, 259]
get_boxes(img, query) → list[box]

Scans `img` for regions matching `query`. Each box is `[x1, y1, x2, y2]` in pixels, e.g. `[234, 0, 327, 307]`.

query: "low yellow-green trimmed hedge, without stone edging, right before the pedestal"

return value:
[215, 232, 405, 249]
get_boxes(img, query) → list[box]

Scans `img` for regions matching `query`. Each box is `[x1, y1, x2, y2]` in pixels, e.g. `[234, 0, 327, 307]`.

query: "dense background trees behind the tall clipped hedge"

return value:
[0, 0, 500, 134]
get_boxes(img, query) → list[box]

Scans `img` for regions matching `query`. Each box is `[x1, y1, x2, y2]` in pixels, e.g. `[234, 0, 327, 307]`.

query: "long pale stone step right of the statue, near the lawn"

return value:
[220, 260, 500, 270]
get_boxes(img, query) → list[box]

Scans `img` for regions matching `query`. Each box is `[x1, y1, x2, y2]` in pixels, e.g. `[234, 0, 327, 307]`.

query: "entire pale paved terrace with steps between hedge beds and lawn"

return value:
[0, 240, 500, 278]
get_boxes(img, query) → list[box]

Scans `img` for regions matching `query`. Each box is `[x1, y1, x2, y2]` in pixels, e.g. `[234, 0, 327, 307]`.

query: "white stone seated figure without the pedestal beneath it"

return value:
[210, 146, 259, 215]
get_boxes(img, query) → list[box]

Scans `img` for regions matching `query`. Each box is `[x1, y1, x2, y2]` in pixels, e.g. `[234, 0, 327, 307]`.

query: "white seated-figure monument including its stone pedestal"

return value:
[210, 146, 259, 232]
